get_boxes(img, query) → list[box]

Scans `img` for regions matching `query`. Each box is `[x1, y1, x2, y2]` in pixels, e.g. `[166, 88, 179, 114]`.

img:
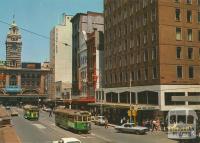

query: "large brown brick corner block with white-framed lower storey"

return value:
[103, 0, 200, 122]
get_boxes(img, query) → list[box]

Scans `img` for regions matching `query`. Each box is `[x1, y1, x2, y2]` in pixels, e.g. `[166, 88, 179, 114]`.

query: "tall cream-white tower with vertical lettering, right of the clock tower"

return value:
[50, 13, 72, 99]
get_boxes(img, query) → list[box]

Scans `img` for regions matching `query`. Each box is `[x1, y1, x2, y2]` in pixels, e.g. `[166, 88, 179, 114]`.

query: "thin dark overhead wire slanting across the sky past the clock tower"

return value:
[0, 20, 71, 46]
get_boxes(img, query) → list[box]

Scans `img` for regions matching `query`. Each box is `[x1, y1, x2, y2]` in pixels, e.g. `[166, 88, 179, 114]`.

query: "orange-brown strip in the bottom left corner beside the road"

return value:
[0, 106, 21, 143]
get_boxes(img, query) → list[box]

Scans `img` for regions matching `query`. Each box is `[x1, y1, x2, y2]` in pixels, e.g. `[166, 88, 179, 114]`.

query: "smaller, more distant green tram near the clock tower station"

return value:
[24, 105, 39, 120]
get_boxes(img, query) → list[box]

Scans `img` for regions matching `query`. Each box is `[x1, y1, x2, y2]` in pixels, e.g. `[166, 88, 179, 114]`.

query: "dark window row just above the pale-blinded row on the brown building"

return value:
[175, 8, 200, 23]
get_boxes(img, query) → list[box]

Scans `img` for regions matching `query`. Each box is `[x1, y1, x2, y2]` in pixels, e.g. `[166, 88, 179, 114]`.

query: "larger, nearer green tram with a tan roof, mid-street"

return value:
[54, 109, 91, 133]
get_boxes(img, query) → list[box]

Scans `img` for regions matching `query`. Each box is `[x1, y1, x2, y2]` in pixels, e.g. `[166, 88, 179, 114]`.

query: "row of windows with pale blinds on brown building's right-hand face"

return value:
[176, 27, 200, 42]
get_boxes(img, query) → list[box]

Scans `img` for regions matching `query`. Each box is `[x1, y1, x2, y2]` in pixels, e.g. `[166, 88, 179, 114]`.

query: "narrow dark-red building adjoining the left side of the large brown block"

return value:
[86, 30, 104, 96]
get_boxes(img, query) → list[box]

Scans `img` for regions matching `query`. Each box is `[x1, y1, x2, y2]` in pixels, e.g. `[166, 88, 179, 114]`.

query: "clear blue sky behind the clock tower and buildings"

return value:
[0, 0, 103, 62]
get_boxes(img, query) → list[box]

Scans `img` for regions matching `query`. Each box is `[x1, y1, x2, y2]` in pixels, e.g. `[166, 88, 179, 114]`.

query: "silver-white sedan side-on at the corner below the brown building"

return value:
[115, 123, 148, 135]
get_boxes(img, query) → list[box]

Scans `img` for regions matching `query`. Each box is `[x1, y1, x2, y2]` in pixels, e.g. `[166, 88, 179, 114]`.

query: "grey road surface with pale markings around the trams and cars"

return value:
[12, 109, 176, 143]
